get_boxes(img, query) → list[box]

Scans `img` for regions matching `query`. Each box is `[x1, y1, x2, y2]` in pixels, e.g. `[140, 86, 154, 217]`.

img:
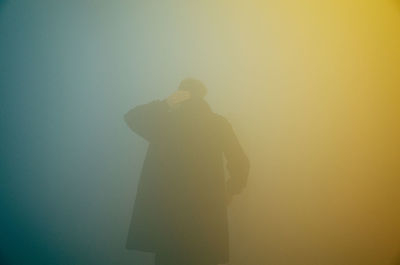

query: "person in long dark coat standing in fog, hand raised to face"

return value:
[125, 79, 249, 265]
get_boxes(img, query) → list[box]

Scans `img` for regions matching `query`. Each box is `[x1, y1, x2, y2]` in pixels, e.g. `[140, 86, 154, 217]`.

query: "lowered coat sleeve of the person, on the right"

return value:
[223, 118, 250, 195]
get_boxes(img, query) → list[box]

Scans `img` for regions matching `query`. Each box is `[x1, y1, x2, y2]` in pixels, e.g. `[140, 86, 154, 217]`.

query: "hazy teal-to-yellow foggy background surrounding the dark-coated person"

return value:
[0, 0, 400, 265]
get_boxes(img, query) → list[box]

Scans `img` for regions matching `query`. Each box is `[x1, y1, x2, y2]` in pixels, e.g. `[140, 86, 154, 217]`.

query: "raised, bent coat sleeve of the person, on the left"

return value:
[124, 100, 169, 142]
